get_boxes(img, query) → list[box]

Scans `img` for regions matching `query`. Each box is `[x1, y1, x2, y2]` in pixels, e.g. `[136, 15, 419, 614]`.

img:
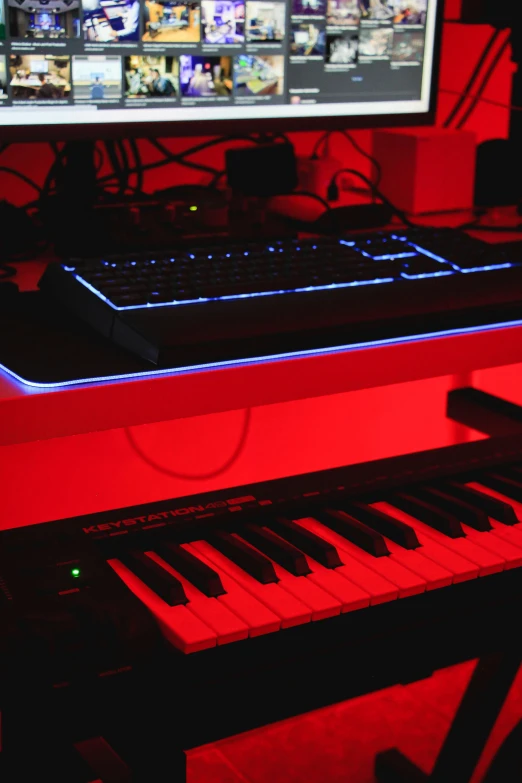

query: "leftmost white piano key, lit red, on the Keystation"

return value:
[108, 559, 217, 654]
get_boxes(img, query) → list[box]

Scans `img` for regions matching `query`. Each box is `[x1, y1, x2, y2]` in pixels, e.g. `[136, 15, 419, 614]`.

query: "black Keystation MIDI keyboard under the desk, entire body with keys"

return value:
[0, 426, 522, 783]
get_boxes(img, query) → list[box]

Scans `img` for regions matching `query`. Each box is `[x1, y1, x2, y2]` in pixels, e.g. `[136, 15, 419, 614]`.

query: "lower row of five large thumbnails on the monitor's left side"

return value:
[0, 54, 285, 107]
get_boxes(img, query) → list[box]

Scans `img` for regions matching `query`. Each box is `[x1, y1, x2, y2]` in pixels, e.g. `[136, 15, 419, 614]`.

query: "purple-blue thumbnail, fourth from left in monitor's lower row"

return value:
[179, 54, 232, 98]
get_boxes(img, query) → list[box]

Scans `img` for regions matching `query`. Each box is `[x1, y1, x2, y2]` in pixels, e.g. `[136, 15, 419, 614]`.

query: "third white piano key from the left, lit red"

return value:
[182, 544, 281, 638]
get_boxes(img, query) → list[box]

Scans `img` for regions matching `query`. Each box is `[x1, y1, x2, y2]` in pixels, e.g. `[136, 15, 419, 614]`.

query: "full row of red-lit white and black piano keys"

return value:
[95, 478, 522, 654]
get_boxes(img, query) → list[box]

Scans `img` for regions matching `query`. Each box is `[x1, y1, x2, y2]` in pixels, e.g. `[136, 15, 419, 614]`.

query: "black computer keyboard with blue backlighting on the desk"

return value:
[40, 228, 522, 364]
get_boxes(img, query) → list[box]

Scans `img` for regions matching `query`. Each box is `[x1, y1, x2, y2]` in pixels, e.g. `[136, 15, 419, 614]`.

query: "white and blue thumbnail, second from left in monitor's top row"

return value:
[83, 0, 140, 44]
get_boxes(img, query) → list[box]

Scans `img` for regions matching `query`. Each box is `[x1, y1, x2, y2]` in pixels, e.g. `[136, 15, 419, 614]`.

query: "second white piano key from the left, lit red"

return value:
[147, 552, 249, 644]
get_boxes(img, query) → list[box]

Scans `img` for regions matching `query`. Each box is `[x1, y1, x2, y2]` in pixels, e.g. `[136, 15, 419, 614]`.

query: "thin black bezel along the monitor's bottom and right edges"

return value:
[0, 0, 444, 143]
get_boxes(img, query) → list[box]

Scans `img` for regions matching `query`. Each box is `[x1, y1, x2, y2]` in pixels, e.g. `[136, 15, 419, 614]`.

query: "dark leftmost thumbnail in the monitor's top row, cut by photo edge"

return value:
[9, 0, 80, 40]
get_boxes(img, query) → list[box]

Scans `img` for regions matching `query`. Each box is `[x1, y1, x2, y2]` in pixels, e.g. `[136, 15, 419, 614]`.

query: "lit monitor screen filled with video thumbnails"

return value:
[0, 0, 442, 135]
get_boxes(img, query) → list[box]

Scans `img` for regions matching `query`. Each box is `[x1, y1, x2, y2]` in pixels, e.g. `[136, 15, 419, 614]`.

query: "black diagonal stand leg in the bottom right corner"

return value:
[375, 649, 522, 783]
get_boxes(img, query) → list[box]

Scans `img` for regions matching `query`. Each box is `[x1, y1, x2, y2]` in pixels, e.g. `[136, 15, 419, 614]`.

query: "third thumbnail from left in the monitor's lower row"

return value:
[125, 55, 179, 101]
